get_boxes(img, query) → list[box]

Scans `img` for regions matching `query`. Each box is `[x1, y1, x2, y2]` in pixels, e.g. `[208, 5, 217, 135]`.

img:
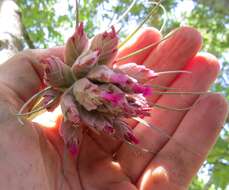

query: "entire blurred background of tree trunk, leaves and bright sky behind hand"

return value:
[0, 0, 229, 190]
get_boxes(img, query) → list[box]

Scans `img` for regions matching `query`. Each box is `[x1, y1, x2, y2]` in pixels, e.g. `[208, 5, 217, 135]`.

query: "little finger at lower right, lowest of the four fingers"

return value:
[139, 94, 228, 190]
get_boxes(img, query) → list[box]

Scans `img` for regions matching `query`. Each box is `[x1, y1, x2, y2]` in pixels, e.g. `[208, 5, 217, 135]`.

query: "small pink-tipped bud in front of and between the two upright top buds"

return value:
[72, 51, 99, 78]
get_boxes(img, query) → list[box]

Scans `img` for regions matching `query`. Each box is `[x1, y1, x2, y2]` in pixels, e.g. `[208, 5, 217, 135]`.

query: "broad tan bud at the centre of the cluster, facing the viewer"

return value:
[73, 78, 102, 111]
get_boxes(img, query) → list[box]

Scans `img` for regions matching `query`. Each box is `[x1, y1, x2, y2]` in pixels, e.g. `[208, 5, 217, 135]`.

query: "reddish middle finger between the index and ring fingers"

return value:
[144, 27, 202, 102]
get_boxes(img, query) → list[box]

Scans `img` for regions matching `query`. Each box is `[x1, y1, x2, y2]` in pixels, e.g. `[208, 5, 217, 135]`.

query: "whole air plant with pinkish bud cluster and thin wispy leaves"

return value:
[17, 1, 204, 183]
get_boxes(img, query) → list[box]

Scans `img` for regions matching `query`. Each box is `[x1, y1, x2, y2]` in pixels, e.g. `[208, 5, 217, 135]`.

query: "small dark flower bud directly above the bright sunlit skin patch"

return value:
[43, 89, 61, 112]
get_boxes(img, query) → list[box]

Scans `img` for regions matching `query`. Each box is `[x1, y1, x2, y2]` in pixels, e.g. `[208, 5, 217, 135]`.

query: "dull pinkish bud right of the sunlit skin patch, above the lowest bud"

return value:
[60, 92, 80, 124]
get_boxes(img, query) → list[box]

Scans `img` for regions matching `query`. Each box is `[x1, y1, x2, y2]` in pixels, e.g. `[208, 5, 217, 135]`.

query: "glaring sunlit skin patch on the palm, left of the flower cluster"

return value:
[32, 106, 62, 128]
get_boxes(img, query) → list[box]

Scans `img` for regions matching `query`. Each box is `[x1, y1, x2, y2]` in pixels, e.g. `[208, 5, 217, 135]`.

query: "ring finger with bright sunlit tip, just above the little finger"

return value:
[119, 54, 219, 183]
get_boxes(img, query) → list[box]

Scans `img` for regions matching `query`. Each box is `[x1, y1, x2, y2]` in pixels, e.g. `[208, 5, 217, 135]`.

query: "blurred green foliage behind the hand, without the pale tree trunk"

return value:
[17, 0, 229, 190]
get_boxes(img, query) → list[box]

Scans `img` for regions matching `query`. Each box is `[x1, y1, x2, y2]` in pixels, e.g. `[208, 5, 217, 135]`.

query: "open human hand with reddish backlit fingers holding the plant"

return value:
[0, 27, 228, 190]
